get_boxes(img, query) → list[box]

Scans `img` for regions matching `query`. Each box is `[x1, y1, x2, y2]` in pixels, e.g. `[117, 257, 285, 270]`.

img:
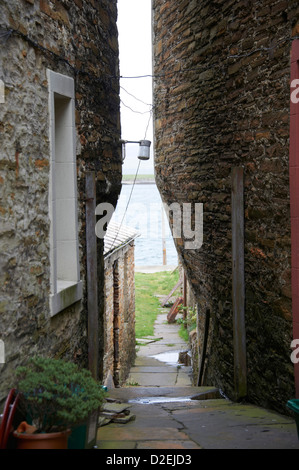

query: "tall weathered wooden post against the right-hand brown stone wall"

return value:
[232, 167, 247, 399]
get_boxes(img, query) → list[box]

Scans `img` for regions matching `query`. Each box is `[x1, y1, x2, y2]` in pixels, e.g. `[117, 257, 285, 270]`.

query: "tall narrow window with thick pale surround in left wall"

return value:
[47, 70, 82, 316]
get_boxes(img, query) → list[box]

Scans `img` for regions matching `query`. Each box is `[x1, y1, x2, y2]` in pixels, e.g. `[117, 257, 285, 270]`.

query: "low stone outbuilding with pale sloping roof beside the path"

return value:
[103, 222, 138, 388]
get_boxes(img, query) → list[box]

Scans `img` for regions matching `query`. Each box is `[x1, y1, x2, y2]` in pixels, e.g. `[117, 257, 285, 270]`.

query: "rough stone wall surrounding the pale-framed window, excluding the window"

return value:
[0, 0, 121, 400]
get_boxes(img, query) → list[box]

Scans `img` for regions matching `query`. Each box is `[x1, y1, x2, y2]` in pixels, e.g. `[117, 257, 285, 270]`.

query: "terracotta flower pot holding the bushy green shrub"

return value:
[13, 430, 71, 449]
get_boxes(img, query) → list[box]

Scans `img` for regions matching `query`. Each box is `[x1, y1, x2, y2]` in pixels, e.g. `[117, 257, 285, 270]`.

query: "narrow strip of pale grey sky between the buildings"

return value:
[118, 0, 153, 174]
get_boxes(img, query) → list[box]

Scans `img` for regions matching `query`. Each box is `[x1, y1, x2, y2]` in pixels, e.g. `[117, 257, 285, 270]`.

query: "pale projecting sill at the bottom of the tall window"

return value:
[50, 281, 82, 317]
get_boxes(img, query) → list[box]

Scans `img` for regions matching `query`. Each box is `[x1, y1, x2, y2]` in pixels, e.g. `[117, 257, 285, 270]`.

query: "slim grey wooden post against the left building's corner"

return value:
[85, 171, 99, 380]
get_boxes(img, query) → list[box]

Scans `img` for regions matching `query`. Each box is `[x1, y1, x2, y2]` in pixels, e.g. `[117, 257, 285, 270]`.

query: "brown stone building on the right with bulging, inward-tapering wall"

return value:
[153, 0, 299, 411]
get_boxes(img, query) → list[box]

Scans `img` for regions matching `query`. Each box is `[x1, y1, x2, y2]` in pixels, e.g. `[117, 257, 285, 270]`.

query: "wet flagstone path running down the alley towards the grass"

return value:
[97, 315, 299, 452]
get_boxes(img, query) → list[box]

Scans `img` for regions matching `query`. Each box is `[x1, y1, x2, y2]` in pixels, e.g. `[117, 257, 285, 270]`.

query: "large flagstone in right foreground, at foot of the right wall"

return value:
[166, 400, 299, 449]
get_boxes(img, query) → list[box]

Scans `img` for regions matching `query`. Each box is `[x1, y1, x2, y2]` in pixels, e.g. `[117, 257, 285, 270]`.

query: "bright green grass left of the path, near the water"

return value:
[135, 270, 179, 338]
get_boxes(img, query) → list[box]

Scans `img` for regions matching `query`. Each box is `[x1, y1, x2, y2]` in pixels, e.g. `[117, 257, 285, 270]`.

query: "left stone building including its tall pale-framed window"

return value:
[0, 0, 122, 400]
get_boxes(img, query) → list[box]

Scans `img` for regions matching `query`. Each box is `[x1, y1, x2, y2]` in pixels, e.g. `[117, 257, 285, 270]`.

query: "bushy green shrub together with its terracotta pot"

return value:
[13, 357, 105, 448]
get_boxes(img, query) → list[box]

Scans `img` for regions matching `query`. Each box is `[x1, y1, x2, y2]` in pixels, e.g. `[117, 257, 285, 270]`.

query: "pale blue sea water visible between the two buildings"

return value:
[113, 183, 178, 266]
